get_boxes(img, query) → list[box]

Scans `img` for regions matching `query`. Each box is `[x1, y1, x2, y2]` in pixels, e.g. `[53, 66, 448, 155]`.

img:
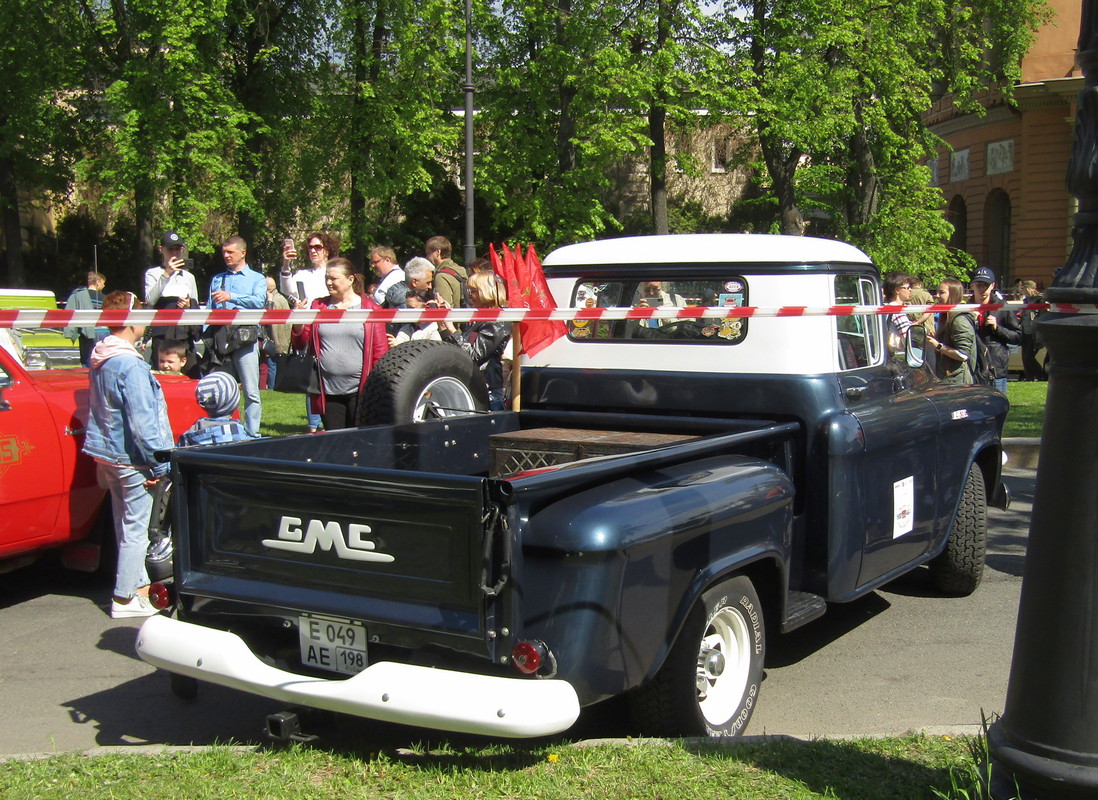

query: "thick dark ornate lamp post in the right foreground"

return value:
[988, 0, 1098, 799]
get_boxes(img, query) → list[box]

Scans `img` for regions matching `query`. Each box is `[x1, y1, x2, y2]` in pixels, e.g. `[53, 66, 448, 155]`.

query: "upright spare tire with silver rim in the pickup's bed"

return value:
[357, 341, 488, 426]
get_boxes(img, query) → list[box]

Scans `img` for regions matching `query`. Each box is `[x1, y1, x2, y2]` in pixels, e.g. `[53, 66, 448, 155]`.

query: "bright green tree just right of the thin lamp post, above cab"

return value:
[477, 0, 650, 248]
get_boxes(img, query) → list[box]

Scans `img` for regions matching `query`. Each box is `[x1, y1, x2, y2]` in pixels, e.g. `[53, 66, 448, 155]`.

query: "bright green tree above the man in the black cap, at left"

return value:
[77, 0, 257, 267]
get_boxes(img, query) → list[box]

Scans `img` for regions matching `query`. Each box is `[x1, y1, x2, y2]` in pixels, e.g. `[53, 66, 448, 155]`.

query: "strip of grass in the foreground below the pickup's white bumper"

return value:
[0, 735, 985, 800]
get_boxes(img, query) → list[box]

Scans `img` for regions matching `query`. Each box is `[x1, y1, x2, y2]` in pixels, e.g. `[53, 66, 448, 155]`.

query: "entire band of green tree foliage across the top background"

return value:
[0, 0, 1046, 278]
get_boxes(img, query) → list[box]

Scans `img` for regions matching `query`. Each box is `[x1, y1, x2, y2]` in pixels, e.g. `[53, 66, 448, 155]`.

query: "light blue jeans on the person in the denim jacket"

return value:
[96, 461, 154, 598]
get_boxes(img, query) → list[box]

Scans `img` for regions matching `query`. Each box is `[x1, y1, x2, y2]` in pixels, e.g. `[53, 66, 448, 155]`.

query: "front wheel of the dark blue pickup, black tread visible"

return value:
[930, 464, 987, 596]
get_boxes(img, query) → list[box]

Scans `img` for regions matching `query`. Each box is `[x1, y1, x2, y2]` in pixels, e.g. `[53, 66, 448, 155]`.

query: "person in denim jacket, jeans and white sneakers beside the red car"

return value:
[83, 292, 173, 619]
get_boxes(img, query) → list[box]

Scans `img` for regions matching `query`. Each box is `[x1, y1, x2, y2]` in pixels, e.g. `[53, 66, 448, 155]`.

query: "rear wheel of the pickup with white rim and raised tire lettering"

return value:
[629, 575, 766, 736]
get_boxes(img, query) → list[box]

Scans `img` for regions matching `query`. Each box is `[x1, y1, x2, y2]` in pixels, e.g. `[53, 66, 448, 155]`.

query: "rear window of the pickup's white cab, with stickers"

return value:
[568, 277, 749, 345]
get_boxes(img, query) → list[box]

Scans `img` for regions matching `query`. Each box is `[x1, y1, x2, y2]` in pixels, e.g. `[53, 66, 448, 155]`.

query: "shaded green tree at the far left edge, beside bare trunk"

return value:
[0, 0, 85, 286]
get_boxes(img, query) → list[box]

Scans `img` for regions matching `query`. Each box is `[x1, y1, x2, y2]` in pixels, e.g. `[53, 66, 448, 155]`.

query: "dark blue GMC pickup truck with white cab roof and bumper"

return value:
[137, 235, 1008, 736]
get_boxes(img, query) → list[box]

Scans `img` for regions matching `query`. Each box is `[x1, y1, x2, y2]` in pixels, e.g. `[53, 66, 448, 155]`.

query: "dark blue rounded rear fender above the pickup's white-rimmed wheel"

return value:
[516, 455, 794, 705]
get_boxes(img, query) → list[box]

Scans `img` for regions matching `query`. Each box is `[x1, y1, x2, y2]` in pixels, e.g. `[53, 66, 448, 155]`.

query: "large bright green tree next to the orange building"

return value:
[720, 0, 1042, 272]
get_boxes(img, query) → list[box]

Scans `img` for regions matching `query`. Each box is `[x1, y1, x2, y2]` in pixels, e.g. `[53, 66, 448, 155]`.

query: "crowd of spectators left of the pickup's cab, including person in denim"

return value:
[66, 232, 511, 619]
